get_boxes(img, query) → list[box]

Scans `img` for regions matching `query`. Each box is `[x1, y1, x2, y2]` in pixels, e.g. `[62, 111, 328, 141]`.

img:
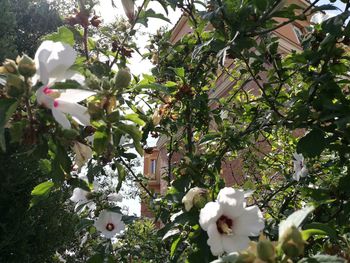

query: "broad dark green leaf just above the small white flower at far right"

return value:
[297, 130, 327, 157]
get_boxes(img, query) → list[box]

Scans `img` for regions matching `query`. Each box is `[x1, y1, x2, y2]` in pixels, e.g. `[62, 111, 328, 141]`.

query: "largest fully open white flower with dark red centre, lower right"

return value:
[199, 187, 264, 256]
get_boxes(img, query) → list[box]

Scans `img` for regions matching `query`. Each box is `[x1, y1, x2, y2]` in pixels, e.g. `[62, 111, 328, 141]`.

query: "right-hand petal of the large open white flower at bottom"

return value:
[233, 205, 265, 236]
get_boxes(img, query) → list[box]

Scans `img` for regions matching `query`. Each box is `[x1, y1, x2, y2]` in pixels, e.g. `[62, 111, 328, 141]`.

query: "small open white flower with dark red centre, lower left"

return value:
[94, 210, 125, 238]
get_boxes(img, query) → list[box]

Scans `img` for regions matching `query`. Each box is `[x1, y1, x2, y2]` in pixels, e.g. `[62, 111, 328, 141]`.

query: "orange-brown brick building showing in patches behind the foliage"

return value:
[141, 0, 309, 217]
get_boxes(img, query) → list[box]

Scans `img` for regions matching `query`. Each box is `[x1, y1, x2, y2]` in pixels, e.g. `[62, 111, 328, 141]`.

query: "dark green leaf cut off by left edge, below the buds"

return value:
[0, 99, 18, 152]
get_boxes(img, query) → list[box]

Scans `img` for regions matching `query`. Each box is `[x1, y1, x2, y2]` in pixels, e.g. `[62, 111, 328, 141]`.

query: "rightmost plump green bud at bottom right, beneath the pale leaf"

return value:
[279, 226, 305, 258]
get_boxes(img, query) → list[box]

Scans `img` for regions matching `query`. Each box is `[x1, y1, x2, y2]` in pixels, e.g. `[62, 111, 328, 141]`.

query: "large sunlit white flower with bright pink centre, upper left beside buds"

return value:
[33, 41, 95, 129]
